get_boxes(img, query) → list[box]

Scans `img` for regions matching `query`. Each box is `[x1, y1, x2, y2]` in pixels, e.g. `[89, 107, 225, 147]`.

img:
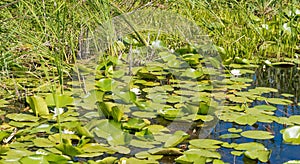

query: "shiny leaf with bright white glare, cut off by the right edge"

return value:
[280, 126, 300, 145]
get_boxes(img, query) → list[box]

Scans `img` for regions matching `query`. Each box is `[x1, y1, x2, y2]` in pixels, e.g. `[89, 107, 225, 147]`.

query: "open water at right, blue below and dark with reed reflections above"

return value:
[211, 67, 300, 164]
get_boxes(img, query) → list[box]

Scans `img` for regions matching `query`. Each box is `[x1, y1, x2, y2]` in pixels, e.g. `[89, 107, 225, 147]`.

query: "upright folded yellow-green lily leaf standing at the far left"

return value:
[26, 96, 49, 116]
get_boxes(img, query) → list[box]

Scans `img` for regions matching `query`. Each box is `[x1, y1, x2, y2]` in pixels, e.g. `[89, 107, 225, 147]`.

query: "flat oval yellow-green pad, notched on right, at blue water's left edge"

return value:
[189, 139, 223, 149]
